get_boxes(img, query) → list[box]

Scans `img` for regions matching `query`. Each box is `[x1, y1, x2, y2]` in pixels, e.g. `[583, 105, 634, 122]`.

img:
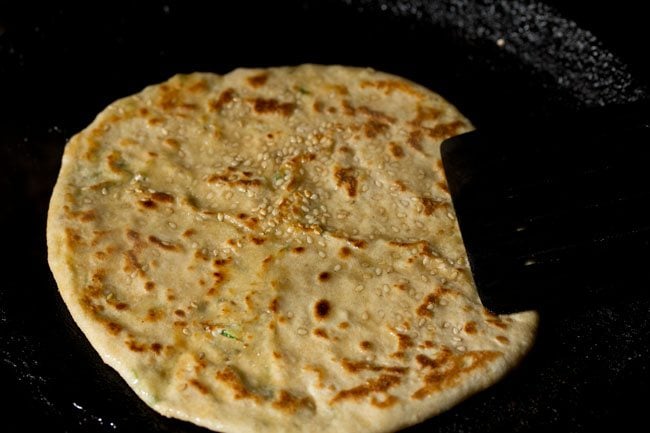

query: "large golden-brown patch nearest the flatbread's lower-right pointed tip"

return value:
[411, 348, 501, 400]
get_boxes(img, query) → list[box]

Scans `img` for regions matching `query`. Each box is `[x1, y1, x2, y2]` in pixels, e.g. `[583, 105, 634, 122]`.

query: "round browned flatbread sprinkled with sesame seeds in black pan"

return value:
[47, 65, 537, 433]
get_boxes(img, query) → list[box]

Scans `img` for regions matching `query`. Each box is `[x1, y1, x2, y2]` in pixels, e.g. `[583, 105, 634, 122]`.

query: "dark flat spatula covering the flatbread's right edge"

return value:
[441, 102, 650, 313]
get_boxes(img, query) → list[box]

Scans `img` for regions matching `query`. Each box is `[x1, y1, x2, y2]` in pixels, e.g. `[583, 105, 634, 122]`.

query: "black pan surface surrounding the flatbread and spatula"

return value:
[0, 0, 650, 432]
